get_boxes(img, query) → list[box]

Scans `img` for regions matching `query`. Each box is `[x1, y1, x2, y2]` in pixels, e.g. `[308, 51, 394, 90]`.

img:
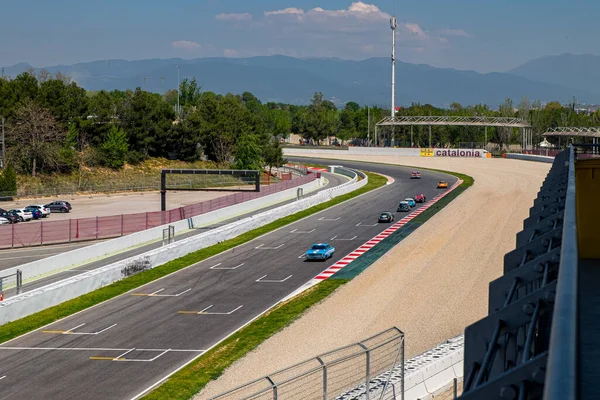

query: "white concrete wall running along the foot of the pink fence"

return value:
[3, 179, 322, 282]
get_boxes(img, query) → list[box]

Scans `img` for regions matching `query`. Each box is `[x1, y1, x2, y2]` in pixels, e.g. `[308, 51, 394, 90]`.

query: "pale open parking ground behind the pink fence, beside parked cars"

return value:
[0, 191, 238, 223]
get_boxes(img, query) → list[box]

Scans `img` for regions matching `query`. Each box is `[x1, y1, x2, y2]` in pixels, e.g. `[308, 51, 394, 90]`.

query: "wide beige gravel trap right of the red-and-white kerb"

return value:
[196, 152, 551, 399]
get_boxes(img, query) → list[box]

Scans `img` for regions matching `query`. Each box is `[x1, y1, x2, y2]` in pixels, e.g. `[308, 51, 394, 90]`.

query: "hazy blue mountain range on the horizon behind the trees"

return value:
[4, 54, 600, 107]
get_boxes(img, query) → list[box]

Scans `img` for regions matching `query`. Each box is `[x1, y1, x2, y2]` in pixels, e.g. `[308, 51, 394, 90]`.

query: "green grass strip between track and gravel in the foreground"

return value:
[144, 279, 346, 400]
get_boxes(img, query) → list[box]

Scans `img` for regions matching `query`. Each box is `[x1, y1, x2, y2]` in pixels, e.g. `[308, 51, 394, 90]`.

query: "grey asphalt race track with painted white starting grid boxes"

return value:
[0, 160, 456, 399]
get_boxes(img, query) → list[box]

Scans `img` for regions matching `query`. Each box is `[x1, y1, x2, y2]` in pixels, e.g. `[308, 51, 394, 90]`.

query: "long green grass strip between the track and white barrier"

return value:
[0, 173, 387, 343]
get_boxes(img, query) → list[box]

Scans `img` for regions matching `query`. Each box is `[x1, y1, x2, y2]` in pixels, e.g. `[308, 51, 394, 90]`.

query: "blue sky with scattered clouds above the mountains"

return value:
[0, 0, 600, 72]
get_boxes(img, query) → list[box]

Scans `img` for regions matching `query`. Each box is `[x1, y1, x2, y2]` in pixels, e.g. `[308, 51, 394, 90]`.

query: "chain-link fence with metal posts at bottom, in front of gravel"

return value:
[210, 328, 404, 400]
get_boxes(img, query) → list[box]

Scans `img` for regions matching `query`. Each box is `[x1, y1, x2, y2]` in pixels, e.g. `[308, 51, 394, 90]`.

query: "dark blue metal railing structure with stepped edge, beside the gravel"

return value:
[460, 147, 578, 400]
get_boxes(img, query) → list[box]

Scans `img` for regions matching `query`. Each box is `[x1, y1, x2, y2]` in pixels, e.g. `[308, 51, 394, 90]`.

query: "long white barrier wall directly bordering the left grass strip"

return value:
[0, 167, 368, 325]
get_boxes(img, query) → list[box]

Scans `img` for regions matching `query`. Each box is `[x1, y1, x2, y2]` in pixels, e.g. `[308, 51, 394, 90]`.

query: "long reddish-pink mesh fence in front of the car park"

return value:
[0, 173, 318, 249]
